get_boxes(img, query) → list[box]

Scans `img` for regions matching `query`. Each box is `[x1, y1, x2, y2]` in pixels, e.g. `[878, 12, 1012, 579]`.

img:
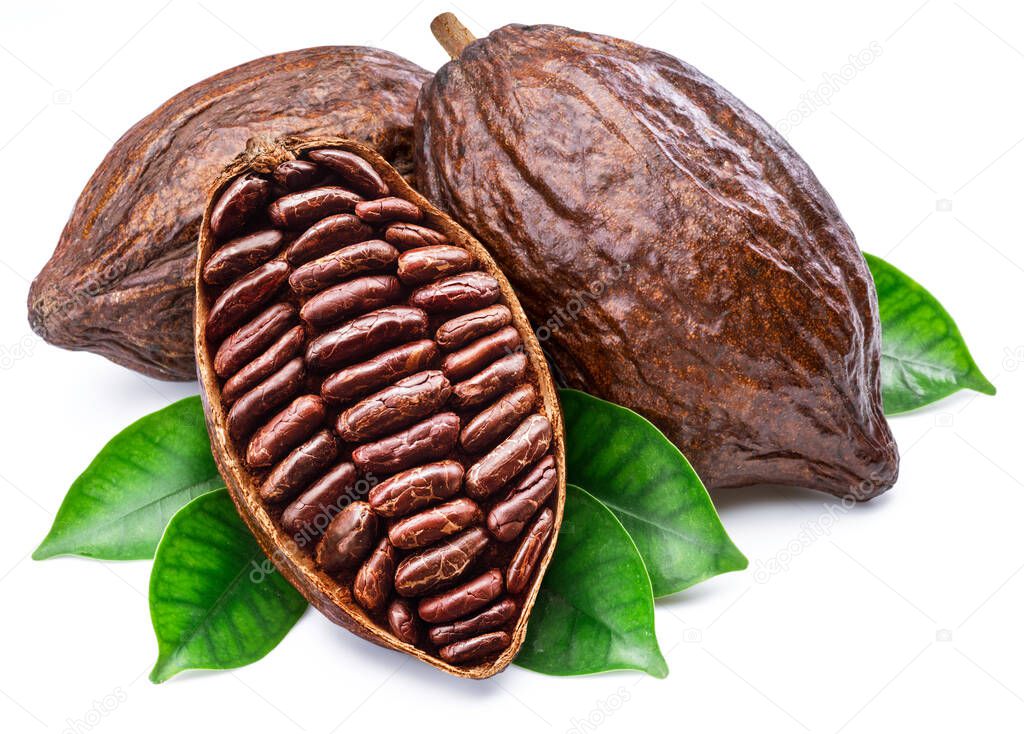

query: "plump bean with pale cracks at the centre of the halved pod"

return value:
[335, 370, 452, 442]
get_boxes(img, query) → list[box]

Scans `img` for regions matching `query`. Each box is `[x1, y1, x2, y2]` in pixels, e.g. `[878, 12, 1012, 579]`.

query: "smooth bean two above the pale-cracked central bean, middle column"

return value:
[306, 306, 429, 370]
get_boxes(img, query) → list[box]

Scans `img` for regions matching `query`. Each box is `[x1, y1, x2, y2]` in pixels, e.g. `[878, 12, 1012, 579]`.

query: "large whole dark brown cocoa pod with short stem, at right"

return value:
[415, 16, 899, 500]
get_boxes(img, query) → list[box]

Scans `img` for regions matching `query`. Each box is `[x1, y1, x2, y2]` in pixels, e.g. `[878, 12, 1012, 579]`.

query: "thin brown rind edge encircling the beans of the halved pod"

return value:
[195, 138, 565, 679]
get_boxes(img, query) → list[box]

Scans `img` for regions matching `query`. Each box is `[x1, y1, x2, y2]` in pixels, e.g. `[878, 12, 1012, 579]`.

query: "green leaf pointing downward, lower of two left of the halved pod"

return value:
[150, 489, 306, 683]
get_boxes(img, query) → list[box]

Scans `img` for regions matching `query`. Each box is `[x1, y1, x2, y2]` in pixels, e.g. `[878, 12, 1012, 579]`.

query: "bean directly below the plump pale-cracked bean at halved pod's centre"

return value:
[352, 413, 459, 474]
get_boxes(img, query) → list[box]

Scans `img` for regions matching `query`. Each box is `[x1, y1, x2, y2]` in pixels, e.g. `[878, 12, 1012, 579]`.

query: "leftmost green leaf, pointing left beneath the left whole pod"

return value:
[32, 397, 224, 560]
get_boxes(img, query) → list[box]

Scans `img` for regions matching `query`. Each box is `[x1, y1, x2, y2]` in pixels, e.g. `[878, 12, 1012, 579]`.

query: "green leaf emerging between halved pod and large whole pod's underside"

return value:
[559, 390, 746, 597]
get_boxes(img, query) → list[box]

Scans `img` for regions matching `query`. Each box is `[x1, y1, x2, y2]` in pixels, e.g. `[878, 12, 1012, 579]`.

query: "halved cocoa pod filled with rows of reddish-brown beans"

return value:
[196, 138, 565, 678]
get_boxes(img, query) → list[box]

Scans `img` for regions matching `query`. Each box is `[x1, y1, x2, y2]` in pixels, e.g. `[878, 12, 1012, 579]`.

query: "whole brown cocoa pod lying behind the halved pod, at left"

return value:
[29, 46, 429, 380]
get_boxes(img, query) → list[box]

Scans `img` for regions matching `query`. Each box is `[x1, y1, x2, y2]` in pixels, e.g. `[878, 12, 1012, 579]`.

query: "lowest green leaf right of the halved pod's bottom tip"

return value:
[515, 484, 669, 678]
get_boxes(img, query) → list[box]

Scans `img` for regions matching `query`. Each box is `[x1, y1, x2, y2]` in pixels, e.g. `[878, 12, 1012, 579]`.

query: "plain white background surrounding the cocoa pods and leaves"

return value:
[0, 0, 1024, 734]
